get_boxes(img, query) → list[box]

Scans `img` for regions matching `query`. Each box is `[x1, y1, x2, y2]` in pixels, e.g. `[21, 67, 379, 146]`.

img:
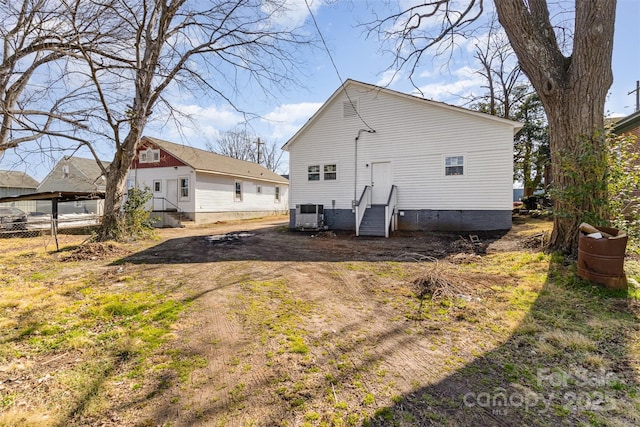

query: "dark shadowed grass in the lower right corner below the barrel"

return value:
[363, 259, 640, 426]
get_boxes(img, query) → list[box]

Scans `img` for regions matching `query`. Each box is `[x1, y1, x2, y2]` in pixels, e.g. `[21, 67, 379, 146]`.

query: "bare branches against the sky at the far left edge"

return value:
[0, 0, 94, 153]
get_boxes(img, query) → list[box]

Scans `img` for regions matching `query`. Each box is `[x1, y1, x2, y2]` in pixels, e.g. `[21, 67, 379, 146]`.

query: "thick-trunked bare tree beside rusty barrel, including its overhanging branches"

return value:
[369, 0, 616, 254]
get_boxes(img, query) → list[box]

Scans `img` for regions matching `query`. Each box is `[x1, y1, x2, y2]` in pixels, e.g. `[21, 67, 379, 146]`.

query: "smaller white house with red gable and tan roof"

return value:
[127, 136, 289, 224]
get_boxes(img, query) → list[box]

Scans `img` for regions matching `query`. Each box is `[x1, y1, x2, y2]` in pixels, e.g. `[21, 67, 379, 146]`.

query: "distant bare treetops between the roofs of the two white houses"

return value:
[207, 129, 283, 172]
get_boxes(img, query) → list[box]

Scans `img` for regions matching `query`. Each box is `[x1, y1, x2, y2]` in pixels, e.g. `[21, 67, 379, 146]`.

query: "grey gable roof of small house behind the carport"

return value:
[38, 156, 110, 192]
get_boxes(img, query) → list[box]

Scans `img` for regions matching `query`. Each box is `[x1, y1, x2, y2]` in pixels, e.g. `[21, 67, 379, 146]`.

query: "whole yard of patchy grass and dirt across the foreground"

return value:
[0, 217, 640, 426]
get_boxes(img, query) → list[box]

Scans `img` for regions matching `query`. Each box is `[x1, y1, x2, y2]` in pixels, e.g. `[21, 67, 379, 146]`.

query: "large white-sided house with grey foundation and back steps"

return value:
[283, 80, 522, 236]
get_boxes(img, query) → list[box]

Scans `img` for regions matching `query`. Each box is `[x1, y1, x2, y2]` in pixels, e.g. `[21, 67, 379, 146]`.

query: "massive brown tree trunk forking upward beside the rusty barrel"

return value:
[495, 0, 616, 254]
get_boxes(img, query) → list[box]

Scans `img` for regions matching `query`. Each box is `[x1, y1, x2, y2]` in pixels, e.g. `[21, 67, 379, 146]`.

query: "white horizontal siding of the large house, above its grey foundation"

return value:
[289, 86, 513, 210]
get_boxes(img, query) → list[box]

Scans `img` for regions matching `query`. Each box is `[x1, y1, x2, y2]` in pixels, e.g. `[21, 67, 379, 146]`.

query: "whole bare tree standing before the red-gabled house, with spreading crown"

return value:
[53, 0, 306, 240]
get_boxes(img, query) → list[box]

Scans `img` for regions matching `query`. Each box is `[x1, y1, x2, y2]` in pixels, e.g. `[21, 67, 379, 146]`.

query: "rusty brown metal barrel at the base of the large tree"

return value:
[578, 227, 628, 289]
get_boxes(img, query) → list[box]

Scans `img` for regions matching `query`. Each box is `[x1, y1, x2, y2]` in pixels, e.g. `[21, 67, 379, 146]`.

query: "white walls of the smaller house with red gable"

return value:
[128, 166, 289, 213]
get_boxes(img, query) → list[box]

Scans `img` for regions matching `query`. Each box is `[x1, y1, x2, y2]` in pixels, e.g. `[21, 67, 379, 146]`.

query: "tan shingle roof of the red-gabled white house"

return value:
[142, 136, 289, 184]
